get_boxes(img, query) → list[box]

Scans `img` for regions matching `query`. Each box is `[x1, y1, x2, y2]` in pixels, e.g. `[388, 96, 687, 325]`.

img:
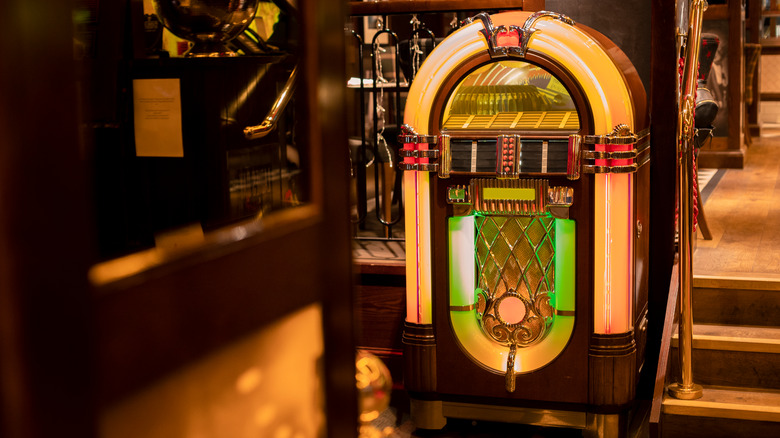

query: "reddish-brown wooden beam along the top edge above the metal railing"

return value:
[349, 0, 544, 15]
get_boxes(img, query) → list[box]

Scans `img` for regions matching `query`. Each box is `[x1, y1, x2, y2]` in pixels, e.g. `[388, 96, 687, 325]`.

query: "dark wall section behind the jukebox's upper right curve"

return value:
[545, 0, 651, 93]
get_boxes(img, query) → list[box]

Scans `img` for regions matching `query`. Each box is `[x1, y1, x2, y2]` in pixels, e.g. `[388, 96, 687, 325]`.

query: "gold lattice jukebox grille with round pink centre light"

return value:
[475, 215, 555, 346]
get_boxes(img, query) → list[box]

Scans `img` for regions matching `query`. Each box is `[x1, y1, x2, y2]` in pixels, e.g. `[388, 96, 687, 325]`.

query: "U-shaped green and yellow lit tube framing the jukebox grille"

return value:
[448, 216, 576, 374]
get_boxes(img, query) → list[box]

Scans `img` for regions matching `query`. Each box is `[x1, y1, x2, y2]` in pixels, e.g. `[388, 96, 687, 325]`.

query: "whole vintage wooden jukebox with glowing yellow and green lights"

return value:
[400, 12, 650, 436]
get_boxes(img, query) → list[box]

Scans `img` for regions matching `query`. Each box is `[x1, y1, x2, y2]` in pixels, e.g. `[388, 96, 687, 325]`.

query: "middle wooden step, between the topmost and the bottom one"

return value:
[671, 324, 780, 390]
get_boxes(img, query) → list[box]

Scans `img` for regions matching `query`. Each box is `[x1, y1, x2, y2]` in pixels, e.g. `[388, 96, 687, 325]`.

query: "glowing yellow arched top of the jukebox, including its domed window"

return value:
[404, 12, 649, 145]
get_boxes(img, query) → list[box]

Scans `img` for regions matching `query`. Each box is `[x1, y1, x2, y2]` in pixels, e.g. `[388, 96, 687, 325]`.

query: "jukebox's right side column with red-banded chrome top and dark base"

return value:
[583, 125, 649, 411]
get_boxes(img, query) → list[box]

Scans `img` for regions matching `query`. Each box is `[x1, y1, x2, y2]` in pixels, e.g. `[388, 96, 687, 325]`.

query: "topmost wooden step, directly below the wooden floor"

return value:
[693, 274, 780, 327]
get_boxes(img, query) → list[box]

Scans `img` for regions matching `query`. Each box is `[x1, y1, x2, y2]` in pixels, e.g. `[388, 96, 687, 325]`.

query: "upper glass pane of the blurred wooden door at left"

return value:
[80, 0, 311, 261]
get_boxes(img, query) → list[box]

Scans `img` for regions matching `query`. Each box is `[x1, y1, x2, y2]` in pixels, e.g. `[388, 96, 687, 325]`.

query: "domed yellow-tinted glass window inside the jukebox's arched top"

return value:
[443, 61, 579, 130]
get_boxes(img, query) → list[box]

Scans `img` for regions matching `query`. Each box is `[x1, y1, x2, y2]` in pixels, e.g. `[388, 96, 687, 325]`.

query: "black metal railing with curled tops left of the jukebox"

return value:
[350, 15, 436, 241]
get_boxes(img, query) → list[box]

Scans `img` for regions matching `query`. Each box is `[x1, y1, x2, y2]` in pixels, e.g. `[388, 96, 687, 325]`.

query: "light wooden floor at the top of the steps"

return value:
[693, 129, 780, 278]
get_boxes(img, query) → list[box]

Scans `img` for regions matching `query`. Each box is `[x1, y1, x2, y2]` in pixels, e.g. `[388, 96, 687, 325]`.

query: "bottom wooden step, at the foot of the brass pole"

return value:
[661, 385, 780, 438]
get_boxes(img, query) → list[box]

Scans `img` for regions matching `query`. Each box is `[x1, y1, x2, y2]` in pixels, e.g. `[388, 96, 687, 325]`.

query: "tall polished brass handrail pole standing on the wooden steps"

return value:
[669, 0, 707, 400]
